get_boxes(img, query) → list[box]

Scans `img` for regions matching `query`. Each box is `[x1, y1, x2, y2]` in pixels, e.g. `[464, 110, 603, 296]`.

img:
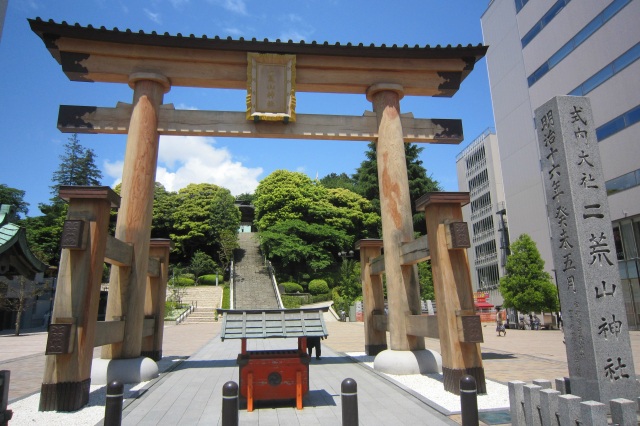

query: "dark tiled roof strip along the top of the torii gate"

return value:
[29, 17, 487, 62]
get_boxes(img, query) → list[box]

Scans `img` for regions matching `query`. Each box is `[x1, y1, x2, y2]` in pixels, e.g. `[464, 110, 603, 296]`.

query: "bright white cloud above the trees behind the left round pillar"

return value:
[105, 136, 263, 195]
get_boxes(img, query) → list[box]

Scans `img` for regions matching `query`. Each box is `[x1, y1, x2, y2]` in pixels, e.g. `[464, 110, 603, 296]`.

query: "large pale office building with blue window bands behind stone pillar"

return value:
[482, 0, 640, 328]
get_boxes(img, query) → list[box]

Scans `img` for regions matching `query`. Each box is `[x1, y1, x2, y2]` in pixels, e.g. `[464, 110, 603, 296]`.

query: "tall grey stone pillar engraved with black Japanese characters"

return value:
[536, 96, 639, 402]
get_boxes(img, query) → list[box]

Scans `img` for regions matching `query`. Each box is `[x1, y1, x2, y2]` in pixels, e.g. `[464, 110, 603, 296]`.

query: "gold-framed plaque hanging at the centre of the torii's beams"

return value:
[247, 53, 296, 123]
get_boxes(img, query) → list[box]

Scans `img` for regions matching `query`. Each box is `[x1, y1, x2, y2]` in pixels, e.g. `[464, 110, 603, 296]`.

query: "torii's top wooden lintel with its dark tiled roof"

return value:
[29, 18, 487, 97]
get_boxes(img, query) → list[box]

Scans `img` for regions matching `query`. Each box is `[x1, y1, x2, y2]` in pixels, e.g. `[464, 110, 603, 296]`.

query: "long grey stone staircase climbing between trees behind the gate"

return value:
[233, 232, 279, 309]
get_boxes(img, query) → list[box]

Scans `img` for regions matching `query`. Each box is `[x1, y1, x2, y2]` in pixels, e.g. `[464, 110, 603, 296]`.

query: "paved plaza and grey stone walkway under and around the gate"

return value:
[0, 317, 640, 425]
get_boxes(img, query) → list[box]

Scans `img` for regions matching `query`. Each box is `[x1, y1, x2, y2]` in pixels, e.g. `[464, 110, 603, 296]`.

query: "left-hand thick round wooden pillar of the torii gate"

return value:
[102, 73, 170, 359]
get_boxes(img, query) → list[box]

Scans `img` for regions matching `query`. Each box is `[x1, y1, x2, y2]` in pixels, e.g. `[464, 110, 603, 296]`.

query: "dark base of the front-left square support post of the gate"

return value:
[38, 379, 91, 411]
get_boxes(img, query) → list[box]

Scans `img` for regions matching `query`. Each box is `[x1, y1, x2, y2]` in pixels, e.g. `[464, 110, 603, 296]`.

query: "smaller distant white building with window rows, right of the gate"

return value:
[456, 129, 509, 305]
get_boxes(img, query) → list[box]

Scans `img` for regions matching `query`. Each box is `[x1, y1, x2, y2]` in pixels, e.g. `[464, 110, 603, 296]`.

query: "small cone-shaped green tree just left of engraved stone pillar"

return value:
[500, 234, 558, 312]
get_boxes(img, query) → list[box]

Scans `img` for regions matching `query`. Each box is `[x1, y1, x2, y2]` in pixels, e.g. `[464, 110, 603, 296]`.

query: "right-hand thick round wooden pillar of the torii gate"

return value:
[367, 84, 425, 351]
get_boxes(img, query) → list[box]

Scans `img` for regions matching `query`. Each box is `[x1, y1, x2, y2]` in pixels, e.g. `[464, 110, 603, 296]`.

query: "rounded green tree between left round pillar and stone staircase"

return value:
[171, 183, 240, 261]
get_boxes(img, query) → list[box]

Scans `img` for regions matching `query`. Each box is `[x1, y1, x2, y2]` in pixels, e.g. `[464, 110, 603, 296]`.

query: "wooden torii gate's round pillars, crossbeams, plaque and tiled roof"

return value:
[29, 18, 487, 410]
